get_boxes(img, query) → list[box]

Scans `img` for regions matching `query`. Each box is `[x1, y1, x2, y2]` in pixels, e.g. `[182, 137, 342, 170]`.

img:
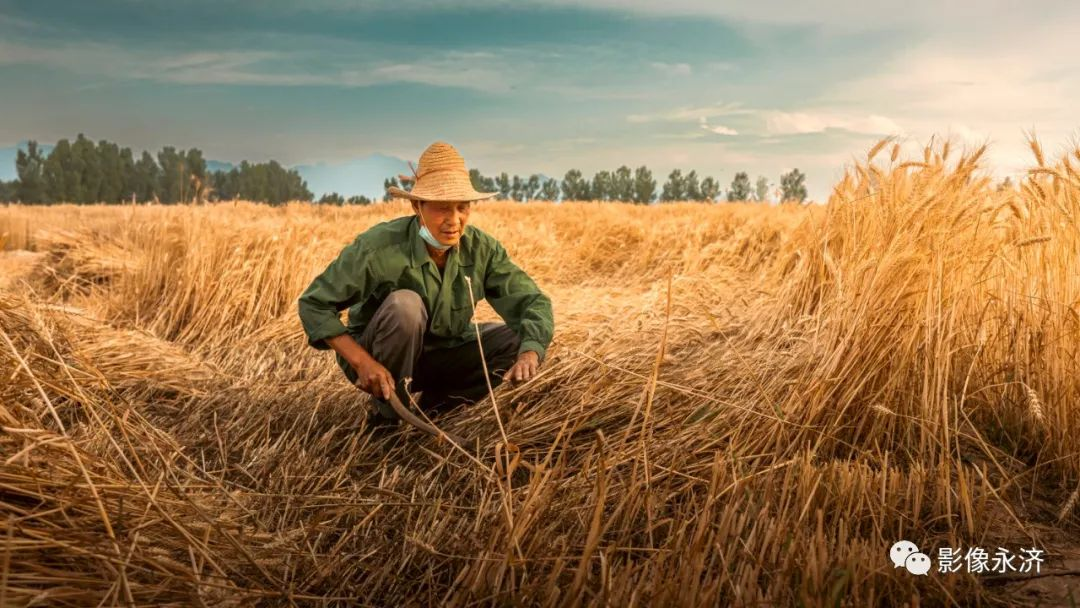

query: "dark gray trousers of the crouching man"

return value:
[338, 289, 522, 418]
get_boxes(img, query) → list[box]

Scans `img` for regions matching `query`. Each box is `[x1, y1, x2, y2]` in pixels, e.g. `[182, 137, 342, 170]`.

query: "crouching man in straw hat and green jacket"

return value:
[299, 141, 554, 424]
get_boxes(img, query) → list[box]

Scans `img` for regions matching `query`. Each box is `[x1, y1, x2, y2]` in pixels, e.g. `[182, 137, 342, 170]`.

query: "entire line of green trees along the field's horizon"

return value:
[0, 134, 807, 205]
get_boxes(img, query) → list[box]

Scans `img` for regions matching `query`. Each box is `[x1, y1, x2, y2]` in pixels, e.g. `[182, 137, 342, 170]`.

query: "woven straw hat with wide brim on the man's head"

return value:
[387, 141, 498, 202]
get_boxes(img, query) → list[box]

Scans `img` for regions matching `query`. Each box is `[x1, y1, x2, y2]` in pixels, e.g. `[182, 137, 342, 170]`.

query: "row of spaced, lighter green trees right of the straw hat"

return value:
[382, 165, 807, 204]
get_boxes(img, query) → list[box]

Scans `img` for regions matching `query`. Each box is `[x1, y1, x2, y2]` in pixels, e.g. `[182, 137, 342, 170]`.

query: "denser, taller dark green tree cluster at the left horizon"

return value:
[0, 133, 313, 204]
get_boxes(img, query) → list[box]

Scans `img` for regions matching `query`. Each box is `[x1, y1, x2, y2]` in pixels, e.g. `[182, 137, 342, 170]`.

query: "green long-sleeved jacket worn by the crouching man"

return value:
[299, 215, 555, 364]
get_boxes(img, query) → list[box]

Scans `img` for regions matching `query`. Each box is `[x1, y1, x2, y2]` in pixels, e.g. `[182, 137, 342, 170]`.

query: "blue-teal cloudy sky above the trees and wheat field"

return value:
[0, 0, 1080, 200]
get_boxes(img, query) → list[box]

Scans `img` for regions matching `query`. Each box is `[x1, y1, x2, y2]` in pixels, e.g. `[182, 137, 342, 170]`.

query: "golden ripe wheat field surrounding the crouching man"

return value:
[0, 143, 1080, 606]
